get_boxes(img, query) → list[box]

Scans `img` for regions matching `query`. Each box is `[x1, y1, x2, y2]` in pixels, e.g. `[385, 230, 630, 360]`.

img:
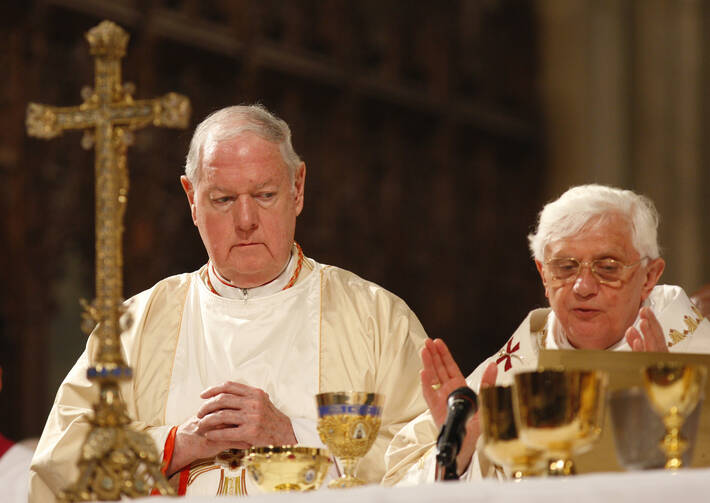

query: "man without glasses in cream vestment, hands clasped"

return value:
[30, 105, 426, 502]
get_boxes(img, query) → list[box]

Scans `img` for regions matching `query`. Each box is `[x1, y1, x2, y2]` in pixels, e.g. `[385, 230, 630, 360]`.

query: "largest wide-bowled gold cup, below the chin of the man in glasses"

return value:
[513, 370, 609, 475]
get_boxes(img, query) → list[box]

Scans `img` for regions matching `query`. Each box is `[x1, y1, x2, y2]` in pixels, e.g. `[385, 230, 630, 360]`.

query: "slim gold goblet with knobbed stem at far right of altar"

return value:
[643, 362, 707, 470]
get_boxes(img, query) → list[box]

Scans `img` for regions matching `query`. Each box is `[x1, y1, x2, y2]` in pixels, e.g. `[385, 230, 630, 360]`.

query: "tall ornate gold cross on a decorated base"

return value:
[26, 21, 190, 501]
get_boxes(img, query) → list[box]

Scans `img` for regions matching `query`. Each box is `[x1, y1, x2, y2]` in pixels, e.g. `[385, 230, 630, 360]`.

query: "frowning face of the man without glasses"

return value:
[181, 133, 306, 288]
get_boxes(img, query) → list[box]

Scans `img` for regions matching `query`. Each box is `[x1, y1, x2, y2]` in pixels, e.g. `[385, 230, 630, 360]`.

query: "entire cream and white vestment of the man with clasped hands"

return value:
[30, 250, 426, 502]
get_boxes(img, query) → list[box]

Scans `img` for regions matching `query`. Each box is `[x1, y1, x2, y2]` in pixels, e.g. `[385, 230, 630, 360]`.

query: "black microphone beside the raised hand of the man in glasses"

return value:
[436, 386, 478, 480]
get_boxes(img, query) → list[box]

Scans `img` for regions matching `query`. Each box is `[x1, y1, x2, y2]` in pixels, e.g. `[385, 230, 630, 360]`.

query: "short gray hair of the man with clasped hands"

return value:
[185, 103, 301, 184]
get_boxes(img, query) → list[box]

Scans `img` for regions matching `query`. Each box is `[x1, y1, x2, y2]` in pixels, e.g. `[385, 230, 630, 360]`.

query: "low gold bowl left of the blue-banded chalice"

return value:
[243, 445, 330, 492]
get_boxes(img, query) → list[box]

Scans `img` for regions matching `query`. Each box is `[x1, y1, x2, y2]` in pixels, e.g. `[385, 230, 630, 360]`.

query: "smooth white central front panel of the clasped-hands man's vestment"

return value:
[165, 254, 335, 495]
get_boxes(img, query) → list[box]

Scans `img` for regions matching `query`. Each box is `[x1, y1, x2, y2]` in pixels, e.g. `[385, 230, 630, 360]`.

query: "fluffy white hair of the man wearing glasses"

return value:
[528, 185, 660, 262]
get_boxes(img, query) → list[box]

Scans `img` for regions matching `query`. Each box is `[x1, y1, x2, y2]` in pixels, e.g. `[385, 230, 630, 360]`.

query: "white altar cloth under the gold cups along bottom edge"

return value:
[136, 468, 710, 503]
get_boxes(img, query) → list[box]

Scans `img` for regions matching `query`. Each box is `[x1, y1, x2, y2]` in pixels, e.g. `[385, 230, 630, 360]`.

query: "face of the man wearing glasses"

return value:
[536, 215, 665, 349]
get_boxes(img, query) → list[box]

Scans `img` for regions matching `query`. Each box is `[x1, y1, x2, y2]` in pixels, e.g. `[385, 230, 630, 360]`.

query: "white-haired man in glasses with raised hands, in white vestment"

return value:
[383, 185, 710, 485]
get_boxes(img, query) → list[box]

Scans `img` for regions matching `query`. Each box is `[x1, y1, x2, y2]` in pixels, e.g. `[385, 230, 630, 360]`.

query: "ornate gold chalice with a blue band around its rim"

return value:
[316, 391, 384, 488]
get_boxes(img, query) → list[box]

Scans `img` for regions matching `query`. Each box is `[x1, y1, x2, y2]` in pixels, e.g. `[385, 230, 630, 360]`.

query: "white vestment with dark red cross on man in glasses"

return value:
[383, 285, 710, 486]
